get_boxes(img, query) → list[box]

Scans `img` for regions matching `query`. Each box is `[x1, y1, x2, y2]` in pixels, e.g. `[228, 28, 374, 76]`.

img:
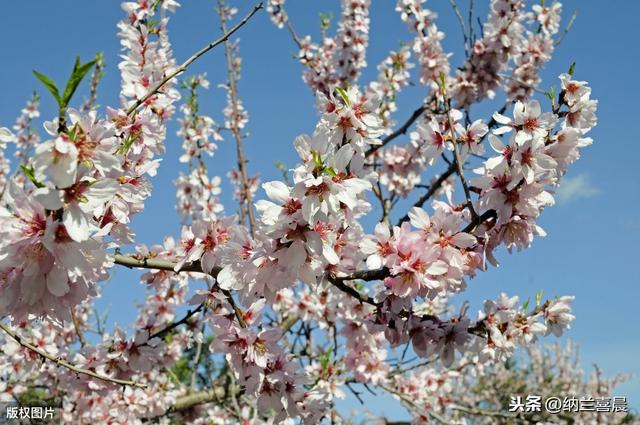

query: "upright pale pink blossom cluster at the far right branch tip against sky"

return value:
[472, 79, 597, 256]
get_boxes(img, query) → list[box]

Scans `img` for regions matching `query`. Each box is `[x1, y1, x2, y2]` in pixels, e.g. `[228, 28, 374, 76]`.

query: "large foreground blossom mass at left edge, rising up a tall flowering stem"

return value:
[0, 1, 179, 319]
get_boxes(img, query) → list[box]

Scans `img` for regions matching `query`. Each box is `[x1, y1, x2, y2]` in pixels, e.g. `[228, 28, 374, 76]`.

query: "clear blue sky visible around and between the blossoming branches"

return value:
[0, 0, 640, 416]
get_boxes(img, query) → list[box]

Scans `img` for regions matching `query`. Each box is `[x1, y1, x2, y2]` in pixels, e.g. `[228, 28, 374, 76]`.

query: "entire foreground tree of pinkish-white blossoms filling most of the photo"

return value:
[0, 0, 612, 424]
